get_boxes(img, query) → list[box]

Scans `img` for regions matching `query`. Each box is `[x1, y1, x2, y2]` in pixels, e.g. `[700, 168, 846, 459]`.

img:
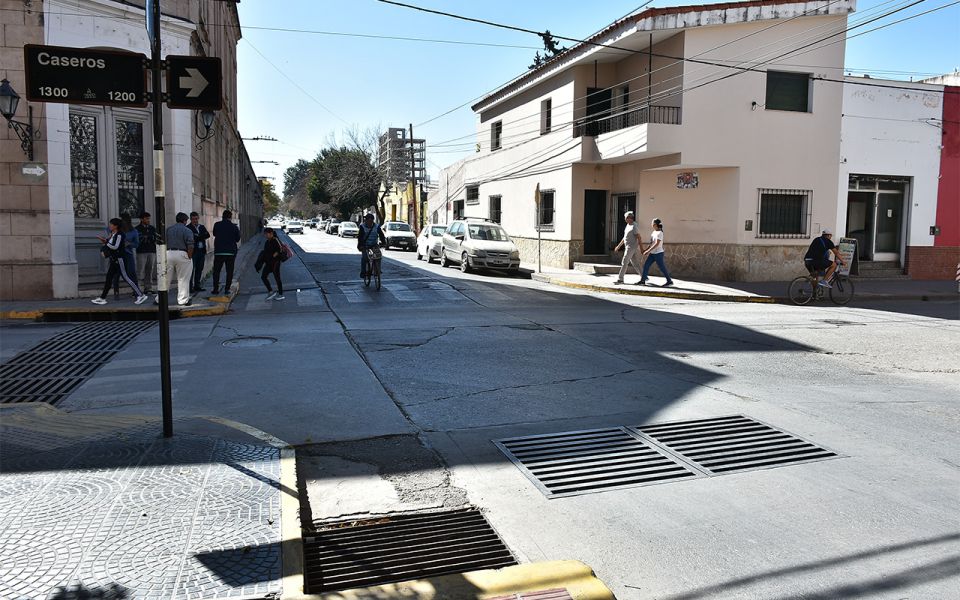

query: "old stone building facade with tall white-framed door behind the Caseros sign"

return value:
[0, 0, 262, 300]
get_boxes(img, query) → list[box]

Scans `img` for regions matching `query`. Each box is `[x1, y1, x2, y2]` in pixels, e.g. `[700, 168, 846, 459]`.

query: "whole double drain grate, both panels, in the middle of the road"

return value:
[502, 415, 839, 498]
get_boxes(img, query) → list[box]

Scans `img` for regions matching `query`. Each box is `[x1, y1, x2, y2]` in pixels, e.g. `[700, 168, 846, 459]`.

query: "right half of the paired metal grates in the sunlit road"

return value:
[636, 415, 837, 474]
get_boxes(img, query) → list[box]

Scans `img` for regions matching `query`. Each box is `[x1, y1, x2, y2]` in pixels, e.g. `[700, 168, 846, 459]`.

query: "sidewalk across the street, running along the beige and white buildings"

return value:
[522, 264, 960, 304]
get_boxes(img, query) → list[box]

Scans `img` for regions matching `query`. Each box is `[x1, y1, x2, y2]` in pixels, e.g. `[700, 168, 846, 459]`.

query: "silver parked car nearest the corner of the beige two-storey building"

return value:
[440, 218, 520, 273]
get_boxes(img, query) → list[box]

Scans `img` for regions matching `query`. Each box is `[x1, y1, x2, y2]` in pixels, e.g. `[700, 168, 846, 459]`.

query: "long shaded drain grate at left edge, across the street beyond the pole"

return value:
[0, 321, 153, 404]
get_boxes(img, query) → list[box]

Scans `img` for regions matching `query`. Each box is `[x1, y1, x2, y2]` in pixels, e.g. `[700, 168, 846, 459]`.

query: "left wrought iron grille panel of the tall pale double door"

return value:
[70, 113, 100, 219]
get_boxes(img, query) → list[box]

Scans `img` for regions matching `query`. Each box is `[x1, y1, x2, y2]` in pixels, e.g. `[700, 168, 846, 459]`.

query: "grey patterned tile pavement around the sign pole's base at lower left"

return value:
[0, 405, 281, 600]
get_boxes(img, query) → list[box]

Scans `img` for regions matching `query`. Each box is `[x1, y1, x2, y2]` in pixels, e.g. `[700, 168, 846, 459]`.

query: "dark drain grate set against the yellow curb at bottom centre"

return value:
[304, 508, 517, 594]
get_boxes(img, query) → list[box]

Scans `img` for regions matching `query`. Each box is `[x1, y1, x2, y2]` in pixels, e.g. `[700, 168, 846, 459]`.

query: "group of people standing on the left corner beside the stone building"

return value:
[93, 210, 240, 306]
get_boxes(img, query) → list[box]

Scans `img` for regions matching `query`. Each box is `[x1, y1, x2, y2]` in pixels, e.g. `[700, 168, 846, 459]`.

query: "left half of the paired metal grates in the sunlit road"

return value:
[494, 427, 698, 498]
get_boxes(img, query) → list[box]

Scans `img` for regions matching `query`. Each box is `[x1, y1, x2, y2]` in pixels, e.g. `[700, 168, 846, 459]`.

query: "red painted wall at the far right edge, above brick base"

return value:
[933, 86, 960, 247]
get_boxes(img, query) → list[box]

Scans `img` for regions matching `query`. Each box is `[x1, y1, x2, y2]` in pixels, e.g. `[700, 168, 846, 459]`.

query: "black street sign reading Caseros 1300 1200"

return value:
[23, 44, 147, 106]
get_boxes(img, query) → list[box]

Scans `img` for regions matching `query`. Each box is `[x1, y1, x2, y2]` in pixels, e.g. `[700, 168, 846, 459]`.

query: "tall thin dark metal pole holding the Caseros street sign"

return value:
[146, 0, 173, 437]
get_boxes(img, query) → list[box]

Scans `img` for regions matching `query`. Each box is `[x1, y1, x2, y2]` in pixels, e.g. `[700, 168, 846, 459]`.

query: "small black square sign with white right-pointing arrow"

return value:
[166, 56, 223, 110]
